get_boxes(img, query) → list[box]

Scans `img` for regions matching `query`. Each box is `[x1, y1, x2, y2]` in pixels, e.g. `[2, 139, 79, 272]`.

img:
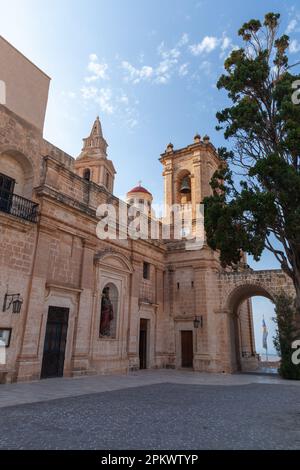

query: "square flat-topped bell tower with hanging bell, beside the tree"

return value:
[160, 134, 220, 227]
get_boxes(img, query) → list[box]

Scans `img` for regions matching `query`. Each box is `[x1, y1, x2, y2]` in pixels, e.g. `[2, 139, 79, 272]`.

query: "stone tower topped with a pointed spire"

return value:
[75, 116, 116, 193]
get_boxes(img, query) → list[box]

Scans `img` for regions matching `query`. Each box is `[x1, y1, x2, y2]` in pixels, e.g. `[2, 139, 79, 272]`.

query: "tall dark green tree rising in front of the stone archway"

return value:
[204, 13, 300, 316]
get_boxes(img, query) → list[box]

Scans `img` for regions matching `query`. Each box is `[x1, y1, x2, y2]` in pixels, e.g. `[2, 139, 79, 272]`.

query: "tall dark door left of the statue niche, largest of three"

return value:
[41, 307, 69, 379]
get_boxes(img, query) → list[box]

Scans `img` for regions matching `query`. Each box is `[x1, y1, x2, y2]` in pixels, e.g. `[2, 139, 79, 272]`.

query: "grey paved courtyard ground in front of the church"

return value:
[0, 371, 300, 450]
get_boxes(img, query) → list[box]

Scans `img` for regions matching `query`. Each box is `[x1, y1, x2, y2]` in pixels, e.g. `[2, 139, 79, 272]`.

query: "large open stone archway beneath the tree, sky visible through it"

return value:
[228, 284, 278, 373]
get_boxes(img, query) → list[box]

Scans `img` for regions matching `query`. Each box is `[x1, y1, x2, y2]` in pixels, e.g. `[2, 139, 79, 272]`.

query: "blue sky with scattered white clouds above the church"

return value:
[0, 0, 300, 352]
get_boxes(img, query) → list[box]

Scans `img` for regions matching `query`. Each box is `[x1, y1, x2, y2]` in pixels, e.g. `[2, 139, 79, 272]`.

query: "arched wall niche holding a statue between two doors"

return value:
[99, 282, 119, 338]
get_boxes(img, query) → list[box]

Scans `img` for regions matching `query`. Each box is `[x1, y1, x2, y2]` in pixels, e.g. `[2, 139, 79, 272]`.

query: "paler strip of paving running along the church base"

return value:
[0, 369, 300, 408]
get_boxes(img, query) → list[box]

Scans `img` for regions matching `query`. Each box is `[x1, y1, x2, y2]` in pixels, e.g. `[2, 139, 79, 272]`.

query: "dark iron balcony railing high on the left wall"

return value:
[0, 191, 39, 223]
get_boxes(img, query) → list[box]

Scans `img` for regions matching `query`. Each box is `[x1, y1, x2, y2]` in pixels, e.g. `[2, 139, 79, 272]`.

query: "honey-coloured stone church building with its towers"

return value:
[0, 35, 256, 382]
